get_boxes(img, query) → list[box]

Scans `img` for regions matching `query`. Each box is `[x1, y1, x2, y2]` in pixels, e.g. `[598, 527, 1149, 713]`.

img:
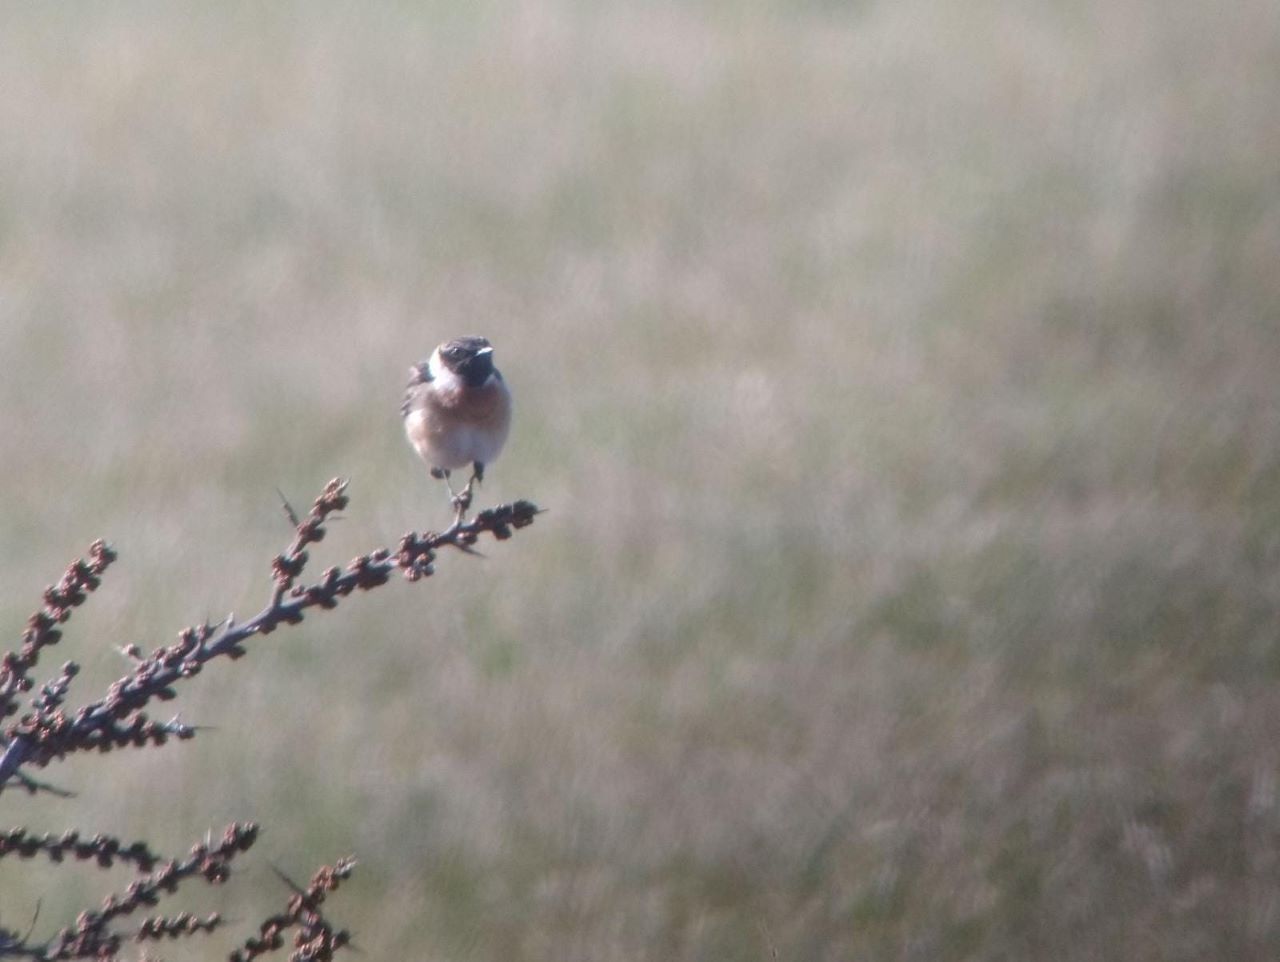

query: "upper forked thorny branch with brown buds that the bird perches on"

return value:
[0, 478, 539, 791]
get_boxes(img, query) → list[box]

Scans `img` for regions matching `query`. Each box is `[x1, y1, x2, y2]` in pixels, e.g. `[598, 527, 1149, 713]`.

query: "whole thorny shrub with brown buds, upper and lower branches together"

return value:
[0, 478, 539, 962]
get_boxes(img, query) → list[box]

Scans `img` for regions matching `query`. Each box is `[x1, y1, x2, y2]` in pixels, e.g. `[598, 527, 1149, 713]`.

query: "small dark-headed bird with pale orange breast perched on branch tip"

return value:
[401, 335, 511, 523]
